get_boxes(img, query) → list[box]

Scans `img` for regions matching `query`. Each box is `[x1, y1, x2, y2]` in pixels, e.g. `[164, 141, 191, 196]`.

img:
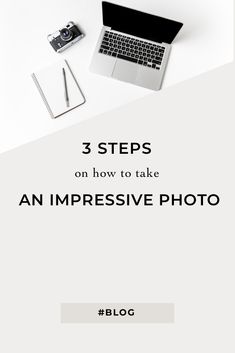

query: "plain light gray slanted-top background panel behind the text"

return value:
[0, 59, 235, 353]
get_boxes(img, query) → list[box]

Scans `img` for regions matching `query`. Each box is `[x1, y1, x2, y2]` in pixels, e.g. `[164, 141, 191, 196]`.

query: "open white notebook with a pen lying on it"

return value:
[32, 60, 86, 118]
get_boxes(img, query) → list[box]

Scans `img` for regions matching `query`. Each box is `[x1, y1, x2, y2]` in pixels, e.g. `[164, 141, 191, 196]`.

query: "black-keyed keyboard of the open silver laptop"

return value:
[99, 31, 165, 70]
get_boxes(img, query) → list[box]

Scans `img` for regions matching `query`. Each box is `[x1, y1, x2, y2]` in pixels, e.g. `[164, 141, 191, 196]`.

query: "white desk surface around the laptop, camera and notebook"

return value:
[0, 0, 233, 152]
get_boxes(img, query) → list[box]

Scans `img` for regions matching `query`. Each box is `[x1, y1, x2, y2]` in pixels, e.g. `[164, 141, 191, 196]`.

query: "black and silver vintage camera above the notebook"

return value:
[47, 21, 84, 53]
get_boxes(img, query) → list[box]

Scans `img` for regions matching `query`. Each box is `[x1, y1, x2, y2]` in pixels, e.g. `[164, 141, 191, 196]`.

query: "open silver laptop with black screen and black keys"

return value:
[90, 1, 183, 91]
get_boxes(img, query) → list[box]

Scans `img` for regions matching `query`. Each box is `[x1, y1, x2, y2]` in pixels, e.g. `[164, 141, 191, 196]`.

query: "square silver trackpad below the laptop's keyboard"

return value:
[112, 59, 138, 83]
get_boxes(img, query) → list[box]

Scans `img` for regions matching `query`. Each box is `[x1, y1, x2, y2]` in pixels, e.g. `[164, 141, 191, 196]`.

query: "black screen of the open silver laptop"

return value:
[102, 1, 183, 44]
